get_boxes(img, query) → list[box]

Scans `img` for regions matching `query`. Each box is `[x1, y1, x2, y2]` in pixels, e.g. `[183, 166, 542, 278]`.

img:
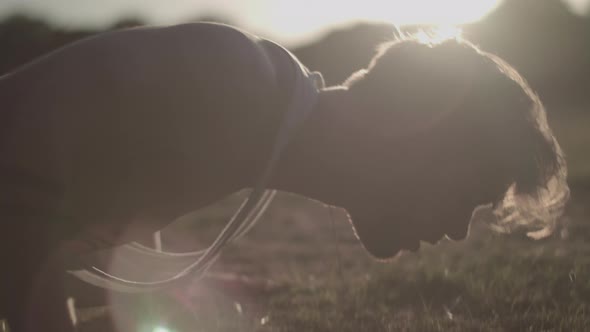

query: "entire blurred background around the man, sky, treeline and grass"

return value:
[0, 0, 590, 331]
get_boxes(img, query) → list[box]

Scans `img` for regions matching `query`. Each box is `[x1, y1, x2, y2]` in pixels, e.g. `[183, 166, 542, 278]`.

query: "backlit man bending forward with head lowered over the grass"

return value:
[0, 23, 567, 331]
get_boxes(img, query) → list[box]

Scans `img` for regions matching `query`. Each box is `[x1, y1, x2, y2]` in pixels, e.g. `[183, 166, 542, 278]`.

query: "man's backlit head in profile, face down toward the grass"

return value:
[344, 33, 568, 258]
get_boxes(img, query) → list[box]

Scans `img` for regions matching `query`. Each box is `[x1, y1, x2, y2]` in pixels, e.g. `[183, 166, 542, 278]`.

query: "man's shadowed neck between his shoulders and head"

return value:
[270, 87, 350, 206]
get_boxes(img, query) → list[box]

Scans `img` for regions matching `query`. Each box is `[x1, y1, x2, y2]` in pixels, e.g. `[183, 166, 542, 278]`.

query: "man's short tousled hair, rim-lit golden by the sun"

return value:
[343, 31, 569, 238]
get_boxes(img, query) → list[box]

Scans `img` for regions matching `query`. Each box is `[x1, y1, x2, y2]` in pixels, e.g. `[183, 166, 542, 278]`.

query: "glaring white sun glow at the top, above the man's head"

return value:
[266, 0, 502, 45]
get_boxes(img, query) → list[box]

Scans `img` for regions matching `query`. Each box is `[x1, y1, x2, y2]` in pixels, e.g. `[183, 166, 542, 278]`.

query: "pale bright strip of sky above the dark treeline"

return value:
[0, 0, 590, 45]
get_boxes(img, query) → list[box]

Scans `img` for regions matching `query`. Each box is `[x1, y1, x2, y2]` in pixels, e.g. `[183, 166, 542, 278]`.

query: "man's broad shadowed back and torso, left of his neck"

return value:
[2, 23, 290, 249]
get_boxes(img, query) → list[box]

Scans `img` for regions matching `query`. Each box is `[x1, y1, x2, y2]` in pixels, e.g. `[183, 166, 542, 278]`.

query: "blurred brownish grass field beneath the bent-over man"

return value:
[70, 185, 590, 332]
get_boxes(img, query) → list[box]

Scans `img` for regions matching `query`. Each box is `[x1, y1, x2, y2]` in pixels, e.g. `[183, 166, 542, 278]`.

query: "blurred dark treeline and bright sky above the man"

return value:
[0, 0, 590, 184]
